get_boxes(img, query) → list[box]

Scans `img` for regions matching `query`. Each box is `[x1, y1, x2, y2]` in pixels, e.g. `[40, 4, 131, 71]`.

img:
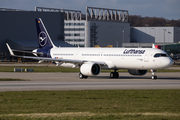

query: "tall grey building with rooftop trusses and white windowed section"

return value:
[36, 7, 130, 47]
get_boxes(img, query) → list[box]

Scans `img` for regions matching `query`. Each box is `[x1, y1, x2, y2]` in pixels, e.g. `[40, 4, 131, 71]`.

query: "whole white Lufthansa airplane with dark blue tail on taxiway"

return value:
[6, 18, 173, 79]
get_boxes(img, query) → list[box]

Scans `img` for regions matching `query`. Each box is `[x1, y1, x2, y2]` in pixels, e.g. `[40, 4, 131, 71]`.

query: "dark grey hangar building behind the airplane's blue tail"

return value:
[0, 8, 68, 60]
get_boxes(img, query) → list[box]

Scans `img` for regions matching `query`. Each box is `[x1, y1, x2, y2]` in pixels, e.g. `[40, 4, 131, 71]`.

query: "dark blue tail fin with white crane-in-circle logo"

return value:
[35, 18, 55, 48]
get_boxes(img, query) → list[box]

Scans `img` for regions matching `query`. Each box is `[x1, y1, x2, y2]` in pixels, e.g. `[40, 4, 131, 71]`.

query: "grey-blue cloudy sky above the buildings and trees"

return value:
[0, 0, 180, 20]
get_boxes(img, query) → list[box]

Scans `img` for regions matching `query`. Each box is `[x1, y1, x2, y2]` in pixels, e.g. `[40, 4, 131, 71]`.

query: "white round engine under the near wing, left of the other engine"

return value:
[80, 63, 101, 76]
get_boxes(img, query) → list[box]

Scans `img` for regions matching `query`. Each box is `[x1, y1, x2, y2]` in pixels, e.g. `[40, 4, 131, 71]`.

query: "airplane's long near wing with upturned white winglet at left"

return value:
[6, 43, 106, 66]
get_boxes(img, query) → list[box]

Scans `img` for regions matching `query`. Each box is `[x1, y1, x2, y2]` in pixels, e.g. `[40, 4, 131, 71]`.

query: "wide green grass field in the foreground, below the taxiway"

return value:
[0, 90, 180, 120]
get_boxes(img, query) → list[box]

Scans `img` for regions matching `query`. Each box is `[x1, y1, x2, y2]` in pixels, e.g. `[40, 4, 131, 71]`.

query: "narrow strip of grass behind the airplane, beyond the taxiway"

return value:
[0, 66, 180, 72]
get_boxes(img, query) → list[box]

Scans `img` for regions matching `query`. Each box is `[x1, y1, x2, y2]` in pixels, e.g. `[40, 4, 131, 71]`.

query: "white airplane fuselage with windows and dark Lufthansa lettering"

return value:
[50, 48, 173, 70]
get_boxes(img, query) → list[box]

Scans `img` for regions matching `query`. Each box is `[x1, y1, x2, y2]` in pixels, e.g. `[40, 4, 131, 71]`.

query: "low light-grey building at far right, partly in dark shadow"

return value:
[123, 27, 180, 47]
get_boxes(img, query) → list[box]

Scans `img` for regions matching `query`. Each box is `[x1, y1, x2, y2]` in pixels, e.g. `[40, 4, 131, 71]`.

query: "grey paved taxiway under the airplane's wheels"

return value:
[0, 72, 180, 91]
